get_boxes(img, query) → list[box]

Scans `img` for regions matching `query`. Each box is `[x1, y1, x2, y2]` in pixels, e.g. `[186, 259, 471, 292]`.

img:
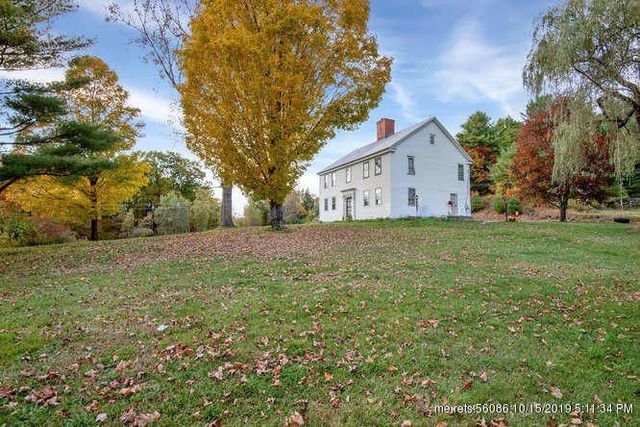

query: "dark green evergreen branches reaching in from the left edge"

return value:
[0, 0, 117, 193]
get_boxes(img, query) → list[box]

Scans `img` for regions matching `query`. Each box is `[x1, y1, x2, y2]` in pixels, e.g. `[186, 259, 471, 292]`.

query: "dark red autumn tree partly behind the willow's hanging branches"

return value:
[513, 107, 613, 221]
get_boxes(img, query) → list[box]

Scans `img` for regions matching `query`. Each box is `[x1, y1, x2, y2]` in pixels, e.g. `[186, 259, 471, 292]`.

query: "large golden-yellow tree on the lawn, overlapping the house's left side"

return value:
[180, 0, 391, 229]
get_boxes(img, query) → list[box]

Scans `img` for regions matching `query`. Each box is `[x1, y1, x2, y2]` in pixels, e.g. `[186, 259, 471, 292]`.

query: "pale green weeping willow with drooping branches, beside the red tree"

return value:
[524, 0, 640, 200]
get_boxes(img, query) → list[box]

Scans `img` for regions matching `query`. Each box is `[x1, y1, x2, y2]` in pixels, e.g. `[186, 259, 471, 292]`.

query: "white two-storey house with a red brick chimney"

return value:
[318, 117, 472, 222]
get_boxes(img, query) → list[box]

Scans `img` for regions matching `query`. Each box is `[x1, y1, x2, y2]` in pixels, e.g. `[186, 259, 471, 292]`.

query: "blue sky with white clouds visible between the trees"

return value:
[0, 0, 558, 213]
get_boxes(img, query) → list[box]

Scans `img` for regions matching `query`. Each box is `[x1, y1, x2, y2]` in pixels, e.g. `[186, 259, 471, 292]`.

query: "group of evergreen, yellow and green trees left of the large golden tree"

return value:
[0, 0, 320, 247]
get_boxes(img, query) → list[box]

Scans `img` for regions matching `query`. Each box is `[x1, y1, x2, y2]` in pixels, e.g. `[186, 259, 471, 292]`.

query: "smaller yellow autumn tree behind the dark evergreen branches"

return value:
[7, 56, 148, 240]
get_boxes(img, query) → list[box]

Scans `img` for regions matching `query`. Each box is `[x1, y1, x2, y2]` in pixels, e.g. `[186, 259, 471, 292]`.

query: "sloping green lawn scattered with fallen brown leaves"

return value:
[0, 220, 640, 426]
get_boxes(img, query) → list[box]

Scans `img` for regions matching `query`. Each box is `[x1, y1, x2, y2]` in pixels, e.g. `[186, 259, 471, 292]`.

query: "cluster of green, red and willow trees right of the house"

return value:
[458, 0, 640, 221]
